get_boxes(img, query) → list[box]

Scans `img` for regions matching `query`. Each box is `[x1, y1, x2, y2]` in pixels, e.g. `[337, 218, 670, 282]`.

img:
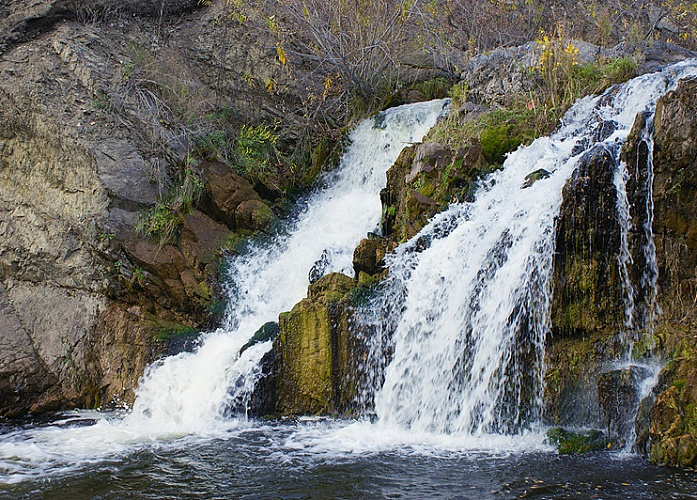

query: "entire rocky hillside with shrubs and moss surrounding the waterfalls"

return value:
[0, 0, 697, 476]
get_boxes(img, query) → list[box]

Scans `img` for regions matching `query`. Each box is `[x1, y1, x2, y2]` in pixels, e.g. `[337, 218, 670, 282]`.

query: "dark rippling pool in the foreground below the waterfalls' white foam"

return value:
[0, 418, 697, 499]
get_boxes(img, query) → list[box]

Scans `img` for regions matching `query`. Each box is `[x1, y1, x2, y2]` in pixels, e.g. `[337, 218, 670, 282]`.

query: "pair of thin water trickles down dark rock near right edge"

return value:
[598, 110, 660, 451]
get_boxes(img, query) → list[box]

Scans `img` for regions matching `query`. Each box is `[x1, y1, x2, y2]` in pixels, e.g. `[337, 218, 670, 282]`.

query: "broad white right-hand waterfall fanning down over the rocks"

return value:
[369, 62, 697, 435]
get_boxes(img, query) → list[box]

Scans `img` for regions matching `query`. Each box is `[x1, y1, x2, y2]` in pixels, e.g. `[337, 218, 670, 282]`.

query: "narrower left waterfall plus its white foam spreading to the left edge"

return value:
[0, 100, 448, 477]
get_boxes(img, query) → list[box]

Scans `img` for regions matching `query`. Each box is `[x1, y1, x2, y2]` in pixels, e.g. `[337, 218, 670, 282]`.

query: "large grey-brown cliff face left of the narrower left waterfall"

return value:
[0, 0, 290, 417]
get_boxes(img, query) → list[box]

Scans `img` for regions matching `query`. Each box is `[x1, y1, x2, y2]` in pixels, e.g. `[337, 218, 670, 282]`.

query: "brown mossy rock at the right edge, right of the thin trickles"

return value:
[644, 79, 697, 467]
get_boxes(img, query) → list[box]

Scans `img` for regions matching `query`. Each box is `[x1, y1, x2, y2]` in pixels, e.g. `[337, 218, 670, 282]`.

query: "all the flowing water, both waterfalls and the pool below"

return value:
[0, 62, 697, 498]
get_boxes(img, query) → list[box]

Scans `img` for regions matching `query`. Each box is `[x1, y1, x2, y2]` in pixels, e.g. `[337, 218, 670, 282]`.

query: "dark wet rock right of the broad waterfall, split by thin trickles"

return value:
[546, 76, 697, 466]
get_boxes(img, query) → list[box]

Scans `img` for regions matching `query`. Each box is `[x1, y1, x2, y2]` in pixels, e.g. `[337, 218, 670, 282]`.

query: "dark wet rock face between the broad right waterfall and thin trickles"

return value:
[545, 141, 624, 426]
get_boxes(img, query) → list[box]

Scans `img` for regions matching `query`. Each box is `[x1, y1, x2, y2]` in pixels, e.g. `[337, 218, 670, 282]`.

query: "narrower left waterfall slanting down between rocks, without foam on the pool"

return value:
[130, 100, 447, 431]
